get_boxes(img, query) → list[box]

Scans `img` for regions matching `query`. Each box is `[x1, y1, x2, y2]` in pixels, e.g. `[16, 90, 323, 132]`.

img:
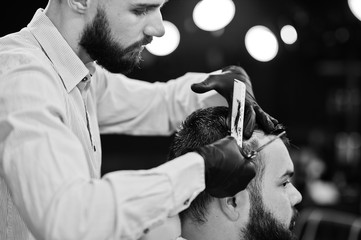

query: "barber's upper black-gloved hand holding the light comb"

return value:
[191, 66, 278, 139]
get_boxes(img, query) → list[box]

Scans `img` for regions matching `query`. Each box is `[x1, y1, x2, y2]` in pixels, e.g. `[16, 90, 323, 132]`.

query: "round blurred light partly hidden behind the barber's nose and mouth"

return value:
[146, 21, 180, 56]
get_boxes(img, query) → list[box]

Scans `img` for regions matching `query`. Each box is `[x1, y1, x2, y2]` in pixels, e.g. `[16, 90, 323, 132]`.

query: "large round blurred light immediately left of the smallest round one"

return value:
[245, 25, 278, 62]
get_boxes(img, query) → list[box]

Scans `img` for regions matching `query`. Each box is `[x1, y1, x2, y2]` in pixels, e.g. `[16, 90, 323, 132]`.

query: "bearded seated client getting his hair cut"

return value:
[169, 107, 302, 240]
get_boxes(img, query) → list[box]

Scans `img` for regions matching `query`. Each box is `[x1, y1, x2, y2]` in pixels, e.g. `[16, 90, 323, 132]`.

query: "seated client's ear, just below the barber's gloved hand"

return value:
[219, 190, 249, 221]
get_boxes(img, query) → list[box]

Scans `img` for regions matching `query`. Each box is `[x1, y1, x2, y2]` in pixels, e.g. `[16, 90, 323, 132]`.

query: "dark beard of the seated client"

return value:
[241, 188, 297, 240]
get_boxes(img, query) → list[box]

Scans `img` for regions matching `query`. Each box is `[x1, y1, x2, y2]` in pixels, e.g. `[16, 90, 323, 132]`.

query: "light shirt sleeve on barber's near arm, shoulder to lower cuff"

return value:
[0, 54, 205, 240]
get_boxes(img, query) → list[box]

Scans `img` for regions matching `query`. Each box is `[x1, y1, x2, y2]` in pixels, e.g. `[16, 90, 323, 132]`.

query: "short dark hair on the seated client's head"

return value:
[168, 107, 286, 224]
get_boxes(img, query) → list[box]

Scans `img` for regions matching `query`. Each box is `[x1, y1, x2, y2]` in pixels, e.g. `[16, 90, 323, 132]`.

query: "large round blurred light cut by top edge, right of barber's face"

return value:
[193, 0, 236, 31]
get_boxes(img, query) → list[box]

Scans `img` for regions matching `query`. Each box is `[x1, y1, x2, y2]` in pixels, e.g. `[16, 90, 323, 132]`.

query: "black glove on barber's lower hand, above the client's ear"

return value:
[196, 136, 256, 198]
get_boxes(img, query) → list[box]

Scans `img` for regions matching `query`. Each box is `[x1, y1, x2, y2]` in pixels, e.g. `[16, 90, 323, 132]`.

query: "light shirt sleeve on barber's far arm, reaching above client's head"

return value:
[96, 66, 227, 135]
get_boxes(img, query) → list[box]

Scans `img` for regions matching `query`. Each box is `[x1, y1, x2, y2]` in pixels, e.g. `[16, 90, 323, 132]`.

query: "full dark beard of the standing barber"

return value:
[79, 8, 152, 74]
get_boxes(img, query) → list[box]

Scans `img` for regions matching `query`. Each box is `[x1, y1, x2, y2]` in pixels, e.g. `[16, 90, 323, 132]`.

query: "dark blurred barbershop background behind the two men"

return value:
[0, 0, 361, 239]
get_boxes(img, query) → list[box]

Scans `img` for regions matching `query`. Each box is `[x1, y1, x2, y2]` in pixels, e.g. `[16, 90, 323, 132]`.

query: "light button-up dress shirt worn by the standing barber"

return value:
[0, 9, 226, 240]
